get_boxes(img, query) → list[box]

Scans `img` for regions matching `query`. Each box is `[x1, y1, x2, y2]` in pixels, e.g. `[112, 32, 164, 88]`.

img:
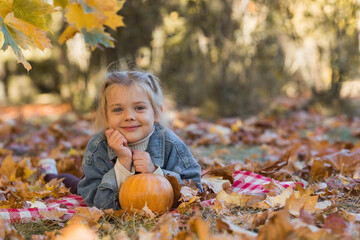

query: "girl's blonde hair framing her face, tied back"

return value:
[94, 71, 168, 131]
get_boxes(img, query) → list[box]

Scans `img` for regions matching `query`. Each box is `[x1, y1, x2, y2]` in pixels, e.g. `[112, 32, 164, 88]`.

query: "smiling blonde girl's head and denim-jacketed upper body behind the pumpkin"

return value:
[77, 71, 202, 209]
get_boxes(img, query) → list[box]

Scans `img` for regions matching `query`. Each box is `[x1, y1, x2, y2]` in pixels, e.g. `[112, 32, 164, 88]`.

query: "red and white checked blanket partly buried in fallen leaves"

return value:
[0, 171, 295, 223]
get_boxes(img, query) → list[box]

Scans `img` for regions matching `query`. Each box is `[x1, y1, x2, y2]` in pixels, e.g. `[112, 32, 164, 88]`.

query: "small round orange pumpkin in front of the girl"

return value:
[119, 173, 174, 213]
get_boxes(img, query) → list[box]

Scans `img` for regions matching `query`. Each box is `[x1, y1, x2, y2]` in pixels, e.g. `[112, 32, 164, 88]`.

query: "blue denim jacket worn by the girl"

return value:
[77, 123, 202, 210]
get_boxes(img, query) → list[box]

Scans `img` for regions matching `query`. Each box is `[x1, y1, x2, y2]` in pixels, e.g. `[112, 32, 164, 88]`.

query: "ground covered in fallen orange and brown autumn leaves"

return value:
[0, 102, 360, 240]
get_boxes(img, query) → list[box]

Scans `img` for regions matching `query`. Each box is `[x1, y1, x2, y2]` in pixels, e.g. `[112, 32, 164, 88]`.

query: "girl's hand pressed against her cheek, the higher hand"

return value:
[105, 128, 132, 171]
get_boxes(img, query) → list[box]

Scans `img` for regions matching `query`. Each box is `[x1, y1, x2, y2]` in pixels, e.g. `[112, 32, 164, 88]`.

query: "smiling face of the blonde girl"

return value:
[106, 85, 156, 143]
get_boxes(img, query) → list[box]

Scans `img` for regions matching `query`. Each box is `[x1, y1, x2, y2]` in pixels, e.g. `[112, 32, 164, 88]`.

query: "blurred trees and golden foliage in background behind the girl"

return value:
[0, 0, 360, 119]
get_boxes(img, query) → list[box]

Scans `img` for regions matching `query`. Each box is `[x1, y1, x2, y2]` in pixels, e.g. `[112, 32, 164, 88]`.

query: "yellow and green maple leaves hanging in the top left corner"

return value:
[0, 0, 124, 71]
